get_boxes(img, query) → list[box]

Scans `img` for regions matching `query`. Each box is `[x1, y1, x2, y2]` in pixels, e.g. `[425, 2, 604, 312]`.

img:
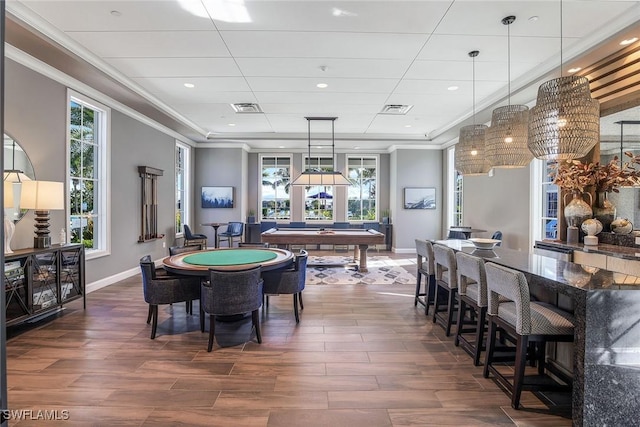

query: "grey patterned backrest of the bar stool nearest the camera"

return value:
[485, 262, 531, 335]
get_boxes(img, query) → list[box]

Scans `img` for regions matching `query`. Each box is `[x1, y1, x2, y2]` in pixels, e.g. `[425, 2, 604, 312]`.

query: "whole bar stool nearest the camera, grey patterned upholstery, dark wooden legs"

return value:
[483, 262, 575, 409]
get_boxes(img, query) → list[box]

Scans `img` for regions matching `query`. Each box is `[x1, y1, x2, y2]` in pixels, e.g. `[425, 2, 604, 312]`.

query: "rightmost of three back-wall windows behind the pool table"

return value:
[347, 157, 378, 221]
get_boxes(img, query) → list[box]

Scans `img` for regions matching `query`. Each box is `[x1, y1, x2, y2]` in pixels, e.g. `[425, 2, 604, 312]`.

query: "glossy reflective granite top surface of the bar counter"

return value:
[434, 239, 640, 295]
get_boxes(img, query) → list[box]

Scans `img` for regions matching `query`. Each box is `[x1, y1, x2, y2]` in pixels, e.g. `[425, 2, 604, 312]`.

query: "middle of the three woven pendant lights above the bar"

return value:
[487, 16, 533, 168]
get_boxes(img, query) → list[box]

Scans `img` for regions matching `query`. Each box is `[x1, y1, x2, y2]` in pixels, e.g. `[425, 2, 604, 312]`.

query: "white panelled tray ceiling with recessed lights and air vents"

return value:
[7, 0, 640, 151]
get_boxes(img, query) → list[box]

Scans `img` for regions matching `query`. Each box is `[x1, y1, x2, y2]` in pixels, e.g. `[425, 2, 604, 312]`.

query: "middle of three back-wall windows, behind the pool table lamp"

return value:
[304, 157, 333, 221]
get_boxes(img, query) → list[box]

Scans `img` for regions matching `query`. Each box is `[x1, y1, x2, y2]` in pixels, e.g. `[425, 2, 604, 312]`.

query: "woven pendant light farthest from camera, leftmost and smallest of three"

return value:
[454, 50, 491, 176]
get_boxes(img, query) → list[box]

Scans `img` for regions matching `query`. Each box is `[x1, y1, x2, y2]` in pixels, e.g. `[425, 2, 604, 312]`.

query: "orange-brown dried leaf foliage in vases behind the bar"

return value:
[550, 152, 640, 193]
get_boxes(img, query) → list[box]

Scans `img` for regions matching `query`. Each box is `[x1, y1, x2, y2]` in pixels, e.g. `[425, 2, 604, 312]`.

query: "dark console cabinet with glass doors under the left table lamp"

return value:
[4, 244, 87, 326]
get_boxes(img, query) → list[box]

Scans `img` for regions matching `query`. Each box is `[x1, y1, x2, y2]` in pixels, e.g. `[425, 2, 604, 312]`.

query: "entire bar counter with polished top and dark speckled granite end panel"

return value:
[434, 240, 640, 426]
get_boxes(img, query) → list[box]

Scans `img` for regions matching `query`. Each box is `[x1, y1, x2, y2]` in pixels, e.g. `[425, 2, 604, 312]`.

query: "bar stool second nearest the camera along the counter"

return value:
[455, 252, 487, 366]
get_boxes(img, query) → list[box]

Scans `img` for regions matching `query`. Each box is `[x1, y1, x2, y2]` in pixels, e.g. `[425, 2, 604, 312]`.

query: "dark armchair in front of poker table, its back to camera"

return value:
[200, 265, 262, 352]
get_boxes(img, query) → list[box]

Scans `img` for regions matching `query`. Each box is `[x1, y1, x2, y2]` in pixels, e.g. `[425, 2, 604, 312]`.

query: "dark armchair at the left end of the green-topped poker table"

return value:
[140, 255, 200, 339]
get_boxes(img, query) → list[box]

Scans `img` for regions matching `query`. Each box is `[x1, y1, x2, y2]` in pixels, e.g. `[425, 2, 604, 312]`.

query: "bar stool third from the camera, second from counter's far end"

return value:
[433, 244, 458, 336]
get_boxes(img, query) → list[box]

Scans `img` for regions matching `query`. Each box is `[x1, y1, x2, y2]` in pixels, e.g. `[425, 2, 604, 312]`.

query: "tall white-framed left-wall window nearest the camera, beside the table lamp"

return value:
[67, 91, 110, 257]
